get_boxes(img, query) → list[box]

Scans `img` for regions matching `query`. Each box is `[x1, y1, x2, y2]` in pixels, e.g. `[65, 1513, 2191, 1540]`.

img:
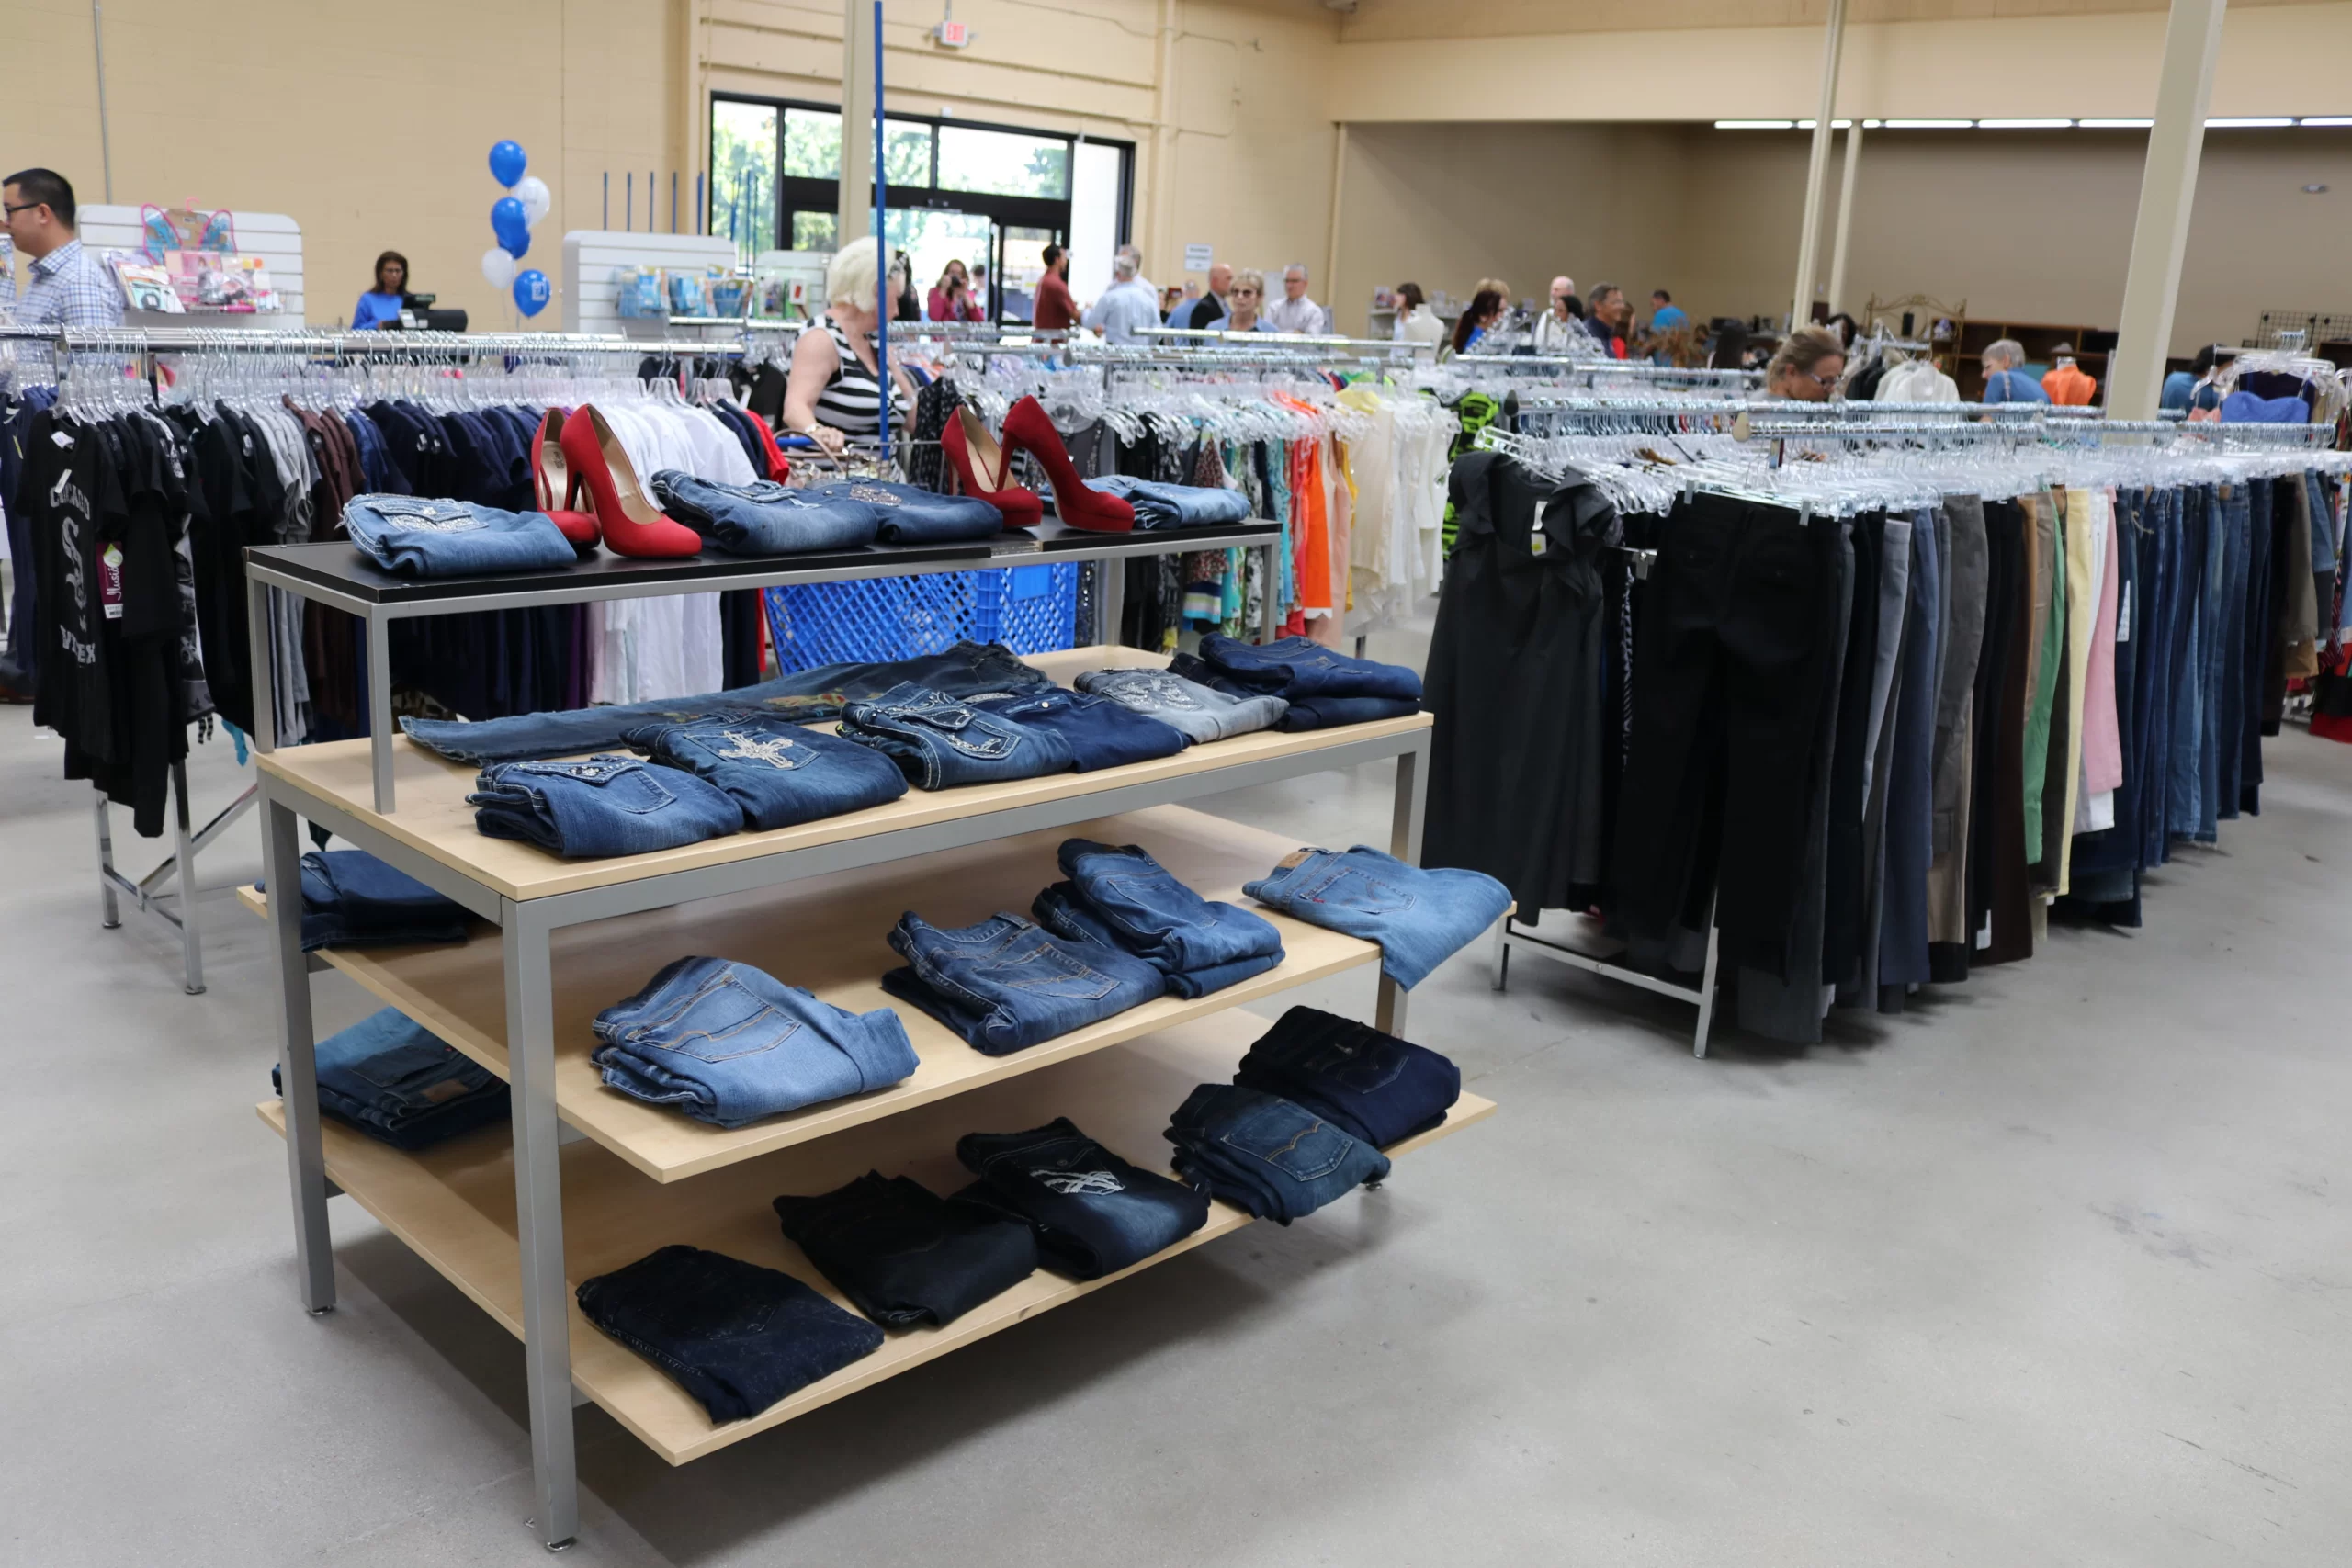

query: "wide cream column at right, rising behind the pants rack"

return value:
[2108, 0, 2222, 419]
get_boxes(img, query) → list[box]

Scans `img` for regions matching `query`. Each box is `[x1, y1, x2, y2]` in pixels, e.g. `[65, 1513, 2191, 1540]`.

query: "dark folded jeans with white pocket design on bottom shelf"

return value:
[955, 1117, 1209, 1279]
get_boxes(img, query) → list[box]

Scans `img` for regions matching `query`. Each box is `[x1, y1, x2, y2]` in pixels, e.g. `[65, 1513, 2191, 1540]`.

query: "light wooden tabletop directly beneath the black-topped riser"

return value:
[256, 647, 1432, 898]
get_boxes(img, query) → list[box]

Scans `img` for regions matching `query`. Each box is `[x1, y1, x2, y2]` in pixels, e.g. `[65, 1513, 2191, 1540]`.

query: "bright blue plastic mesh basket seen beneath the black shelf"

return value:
[764, 562, 1080, 670]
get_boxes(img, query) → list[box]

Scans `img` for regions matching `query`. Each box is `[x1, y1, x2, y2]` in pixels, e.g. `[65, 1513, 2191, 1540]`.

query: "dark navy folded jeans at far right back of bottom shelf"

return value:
[1232, 1006, 1463, 1149]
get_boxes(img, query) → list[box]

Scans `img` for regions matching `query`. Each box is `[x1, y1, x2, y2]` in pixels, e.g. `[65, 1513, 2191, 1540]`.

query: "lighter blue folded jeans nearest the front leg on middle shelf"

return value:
[591, 957, 920, 1126]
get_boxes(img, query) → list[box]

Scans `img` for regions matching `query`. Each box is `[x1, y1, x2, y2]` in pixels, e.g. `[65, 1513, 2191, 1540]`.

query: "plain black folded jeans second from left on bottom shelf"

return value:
[776, 1170, 1037, 1328]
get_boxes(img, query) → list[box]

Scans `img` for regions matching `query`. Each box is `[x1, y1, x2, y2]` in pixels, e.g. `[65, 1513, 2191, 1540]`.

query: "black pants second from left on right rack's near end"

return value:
[1611, 493, 1837, 978]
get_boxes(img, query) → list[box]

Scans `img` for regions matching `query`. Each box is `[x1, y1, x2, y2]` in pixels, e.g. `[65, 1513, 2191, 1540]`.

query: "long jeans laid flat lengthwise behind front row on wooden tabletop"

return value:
[400, 642, 1054, 766]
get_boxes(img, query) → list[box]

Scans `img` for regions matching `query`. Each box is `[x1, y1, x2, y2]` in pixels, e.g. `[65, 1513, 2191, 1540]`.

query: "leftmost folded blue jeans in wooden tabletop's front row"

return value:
[466, 757, 743, 861]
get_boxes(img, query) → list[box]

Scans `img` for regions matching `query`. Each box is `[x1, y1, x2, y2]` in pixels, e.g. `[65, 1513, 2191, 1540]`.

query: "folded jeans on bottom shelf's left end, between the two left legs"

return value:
[270, 1006, 505, 1152]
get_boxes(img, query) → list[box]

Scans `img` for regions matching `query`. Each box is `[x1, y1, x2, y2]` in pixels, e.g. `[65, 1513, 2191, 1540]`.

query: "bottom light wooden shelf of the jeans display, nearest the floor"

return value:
[259, 1010, 1494, 1464]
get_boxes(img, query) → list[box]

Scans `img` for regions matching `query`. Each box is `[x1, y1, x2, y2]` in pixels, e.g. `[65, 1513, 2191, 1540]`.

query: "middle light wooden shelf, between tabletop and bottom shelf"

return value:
[243, 807, 1381, 1182]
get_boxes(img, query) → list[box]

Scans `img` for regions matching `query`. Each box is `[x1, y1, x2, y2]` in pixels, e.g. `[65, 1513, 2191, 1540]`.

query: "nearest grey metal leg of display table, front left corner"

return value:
[499, 900, 579, 1550]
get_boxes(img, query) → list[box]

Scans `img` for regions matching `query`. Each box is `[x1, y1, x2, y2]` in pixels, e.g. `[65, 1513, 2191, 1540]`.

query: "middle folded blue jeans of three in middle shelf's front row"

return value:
[882, 909, 1167, 1055]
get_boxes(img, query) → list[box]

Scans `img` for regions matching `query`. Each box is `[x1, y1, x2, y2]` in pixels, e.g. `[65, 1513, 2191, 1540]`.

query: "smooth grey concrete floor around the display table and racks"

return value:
[0, 620, 2352, 1568]
